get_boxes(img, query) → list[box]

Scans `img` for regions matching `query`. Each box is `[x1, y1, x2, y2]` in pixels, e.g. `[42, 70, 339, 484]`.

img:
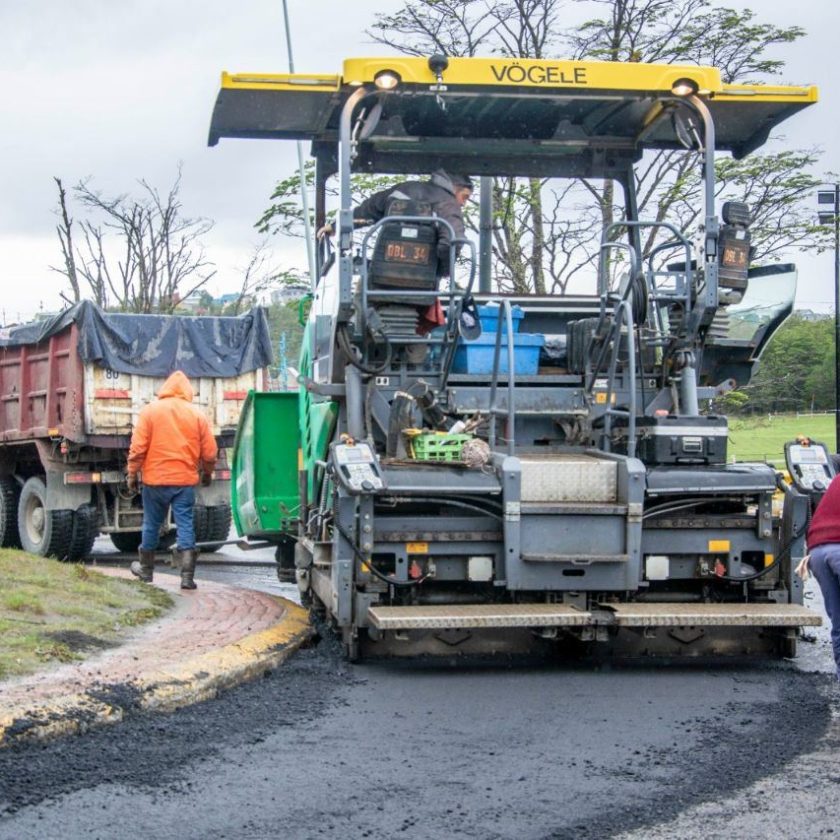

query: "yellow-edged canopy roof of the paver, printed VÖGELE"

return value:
[209, 56, 817, 175]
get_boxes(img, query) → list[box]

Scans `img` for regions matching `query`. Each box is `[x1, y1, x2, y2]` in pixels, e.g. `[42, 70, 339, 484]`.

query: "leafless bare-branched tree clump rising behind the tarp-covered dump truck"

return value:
[54, 167, 216, 313]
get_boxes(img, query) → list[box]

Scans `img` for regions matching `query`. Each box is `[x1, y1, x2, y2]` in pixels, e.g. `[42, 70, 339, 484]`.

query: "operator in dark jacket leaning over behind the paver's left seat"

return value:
[353, 172, 466, 276]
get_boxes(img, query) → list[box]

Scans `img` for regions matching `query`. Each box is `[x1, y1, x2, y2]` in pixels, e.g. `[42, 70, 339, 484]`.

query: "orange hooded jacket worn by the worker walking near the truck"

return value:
[128, 370, 218, 487]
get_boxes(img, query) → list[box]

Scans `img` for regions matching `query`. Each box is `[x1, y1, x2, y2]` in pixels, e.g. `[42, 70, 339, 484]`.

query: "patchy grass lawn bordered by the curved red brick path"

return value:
[0, 549, 173, 680]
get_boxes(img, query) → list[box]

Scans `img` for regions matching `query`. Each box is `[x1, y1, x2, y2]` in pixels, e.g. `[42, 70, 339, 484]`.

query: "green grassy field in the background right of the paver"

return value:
[727, 414, 834, 468]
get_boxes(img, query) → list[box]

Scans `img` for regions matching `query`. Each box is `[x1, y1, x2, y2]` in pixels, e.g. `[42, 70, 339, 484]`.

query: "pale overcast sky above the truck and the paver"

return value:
[0, 0, 840, 322]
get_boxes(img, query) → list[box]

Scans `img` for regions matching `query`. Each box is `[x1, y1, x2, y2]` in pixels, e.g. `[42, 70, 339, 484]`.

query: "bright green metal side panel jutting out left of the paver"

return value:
[232, 391, 300, 537]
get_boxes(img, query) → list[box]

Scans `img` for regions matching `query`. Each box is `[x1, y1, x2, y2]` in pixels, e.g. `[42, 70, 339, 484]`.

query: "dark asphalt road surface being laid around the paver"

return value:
[0, 548, 840, 840]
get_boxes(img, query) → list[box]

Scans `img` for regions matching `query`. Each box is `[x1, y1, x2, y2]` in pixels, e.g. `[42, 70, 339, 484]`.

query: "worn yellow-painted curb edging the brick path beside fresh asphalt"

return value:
[0, 598, 313, 749]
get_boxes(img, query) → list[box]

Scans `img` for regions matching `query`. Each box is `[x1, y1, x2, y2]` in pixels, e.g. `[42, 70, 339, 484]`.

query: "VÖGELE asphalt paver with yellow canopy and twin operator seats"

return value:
[209, 55, 820, 658]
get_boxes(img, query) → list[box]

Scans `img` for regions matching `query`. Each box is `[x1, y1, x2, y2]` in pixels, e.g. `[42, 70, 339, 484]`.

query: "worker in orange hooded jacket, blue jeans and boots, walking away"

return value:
[126, 370, 218, 589]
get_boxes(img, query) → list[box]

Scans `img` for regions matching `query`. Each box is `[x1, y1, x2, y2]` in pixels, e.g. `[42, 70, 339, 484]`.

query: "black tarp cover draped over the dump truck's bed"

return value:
[0, 301, 272, 377]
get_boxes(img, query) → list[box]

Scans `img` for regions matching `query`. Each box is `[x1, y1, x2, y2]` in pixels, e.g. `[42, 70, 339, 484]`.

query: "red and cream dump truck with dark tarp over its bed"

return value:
[0, 301, 271, 560]
